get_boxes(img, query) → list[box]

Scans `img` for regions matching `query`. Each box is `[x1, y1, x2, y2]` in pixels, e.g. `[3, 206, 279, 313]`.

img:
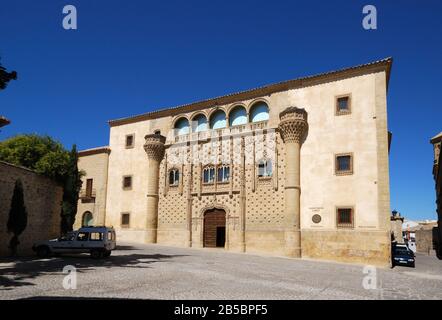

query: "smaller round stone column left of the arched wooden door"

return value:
[144, 134, 166, 243]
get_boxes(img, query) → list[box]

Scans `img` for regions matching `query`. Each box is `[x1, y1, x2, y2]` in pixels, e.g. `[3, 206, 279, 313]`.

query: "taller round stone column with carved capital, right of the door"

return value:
[279, 107, 308, 257]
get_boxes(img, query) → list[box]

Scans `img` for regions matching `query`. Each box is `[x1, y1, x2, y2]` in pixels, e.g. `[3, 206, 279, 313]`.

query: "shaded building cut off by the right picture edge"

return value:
[430, 132, 442, 259]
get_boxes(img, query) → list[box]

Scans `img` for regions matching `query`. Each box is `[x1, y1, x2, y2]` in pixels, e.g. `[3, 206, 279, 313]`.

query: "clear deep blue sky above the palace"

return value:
[0, 0, 442, 219]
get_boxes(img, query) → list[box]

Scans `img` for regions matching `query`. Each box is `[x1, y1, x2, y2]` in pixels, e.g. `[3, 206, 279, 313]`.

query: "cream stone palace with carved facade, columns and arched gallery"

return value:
[76, 58, 392, 266]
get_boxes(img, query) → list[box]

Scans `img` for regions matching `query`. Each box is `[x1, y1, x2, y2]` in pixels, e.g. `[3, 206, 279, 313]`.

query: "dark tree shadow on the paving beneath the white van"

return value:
[0, 251, 184, 291]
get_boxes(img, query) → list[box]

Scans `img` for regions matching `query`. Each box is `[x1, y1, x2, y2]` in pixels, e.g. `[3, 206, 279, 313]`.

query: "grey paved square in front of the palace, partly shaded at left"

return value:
[0, 244, 442, 300]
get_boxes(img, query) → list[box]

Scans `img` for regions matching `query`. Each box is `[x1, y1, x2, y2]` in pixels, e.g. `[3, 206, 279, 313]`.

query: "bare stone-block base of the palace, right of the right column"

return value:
[302, 230, 391, 267]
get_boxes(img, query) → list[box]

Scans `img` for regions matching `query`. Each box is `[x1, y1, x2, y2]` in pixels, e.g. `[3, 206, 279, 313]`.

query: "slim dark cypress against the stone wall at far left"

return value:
[7, 179, 28, 256]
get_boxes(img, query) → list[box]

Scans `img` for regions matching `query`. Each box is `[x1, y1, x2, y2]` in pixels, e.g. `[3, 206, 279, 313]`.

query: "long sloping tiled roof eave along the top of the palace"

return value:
[109, 57, 393, 126]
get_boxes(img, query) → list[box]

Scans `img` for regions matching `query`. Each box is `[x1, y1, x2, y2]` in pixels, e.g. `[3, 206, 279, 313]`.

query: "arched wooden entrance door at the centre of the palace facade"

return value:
[203, 209, 226, 248]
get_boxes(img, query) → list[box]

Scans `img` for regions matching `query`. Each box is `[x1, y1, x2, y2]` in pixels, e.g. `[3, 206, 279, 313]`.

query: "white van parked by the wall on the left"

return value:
[32, 226, 116, 259]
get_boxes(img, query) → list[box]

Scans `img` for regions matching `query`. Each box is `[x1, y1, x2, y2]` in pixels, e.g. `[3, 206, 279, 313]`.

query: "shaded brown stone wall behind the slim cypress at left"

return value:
[0, 161, 63, 256]
